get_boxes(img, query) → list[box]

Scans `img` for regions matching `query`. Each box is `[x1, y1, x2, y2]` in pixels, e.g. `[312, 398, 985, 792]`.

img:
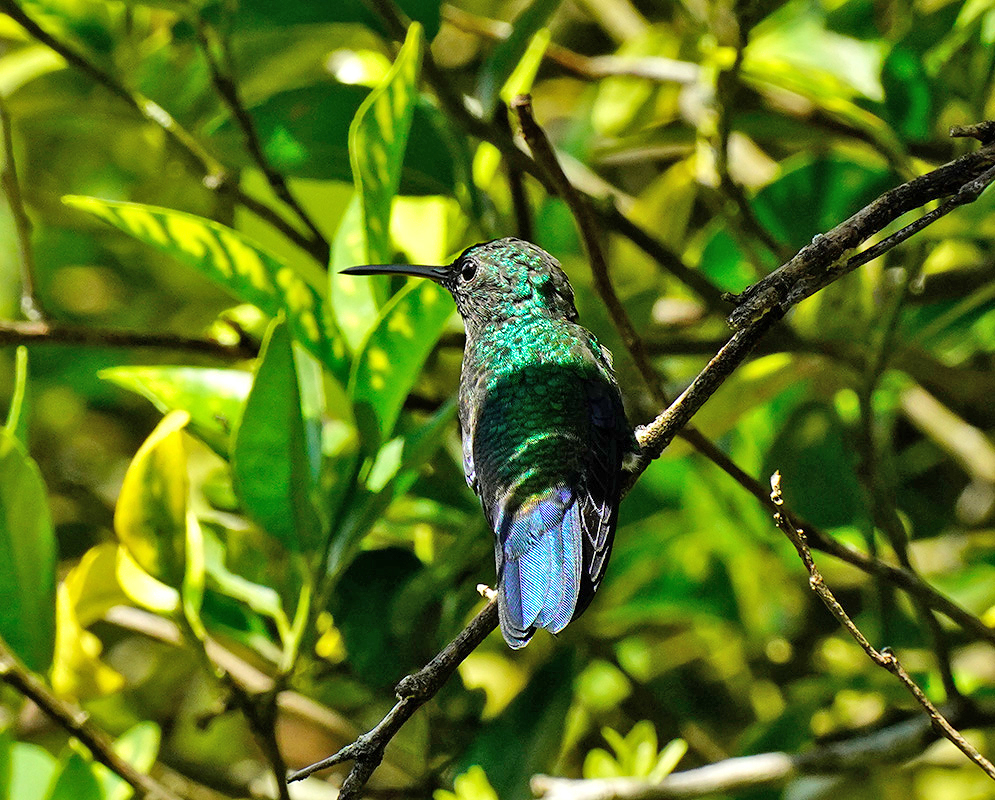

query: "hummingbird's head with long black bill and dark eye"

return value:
[343, 238, 577, 334]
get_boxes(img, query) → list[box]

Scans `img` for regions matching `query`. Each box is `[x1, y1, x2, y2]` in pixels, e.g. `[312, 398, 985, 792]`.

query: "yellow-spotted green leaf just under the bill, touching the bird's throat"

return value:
[349, 278, 453, 447]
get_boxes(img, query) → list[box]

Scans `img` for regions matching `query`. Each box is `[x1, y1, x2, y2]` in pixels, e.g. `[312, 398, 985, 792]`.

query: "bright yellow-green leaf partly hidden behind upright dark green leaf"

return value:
[98, 366, 252, 458]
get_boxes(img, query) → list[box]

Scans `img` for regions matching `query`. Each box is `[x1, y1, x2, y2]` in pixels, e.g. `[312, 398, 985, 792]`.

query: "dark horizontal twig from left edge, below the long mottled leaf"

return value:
[0, 320, 259, 361]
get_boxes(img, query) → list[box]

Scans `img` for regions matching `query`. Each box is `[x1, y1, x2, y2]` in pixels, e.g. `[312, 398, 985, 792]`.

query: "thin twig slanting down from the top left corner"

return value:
[0, 0, 327, 265]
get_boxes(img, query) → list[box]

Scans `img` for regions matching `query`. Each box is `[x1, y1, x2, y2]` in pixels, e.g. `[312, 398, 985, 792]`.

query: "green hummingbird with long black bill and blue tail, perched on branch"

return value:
[343, 238, 637, 649]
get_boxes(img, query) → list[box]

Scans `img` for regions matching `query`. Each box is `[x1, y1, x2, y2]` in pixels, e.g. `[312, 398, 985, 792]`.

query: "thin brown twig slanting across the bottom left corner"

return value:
[0, 639, 186, 800]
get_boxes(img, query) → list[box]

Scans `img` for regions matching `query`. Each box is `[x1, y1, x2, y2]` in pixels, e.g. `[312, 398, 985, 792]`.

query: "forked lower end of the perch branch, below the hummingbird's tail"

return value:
[287, 599, 498, 800]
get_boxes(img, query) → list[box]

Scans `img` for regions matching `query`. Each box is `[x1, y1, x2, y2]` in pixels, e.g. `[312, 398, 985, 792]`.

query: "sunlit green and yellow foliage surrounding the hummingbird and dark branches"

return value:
[0, 0, 995, 800]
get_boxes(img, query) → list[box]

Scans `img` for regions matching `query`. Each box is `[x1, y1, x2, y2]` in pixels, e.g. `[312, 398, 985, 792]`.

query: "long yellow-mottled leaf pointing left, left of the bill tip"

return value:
[62, 195, 344, 374]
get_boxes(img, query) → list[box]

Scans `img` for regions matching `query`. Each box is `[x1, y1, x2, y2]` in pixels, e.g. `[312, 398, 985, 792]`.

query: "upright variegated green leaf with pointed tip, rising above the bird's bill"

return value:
[349, 24, 422, 264]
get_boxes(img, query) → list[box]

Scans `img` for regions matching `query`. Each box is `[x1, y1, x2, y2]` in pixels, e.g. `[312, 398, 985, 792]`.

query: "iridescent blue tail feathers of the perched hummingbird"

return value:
[495, 486, 583, 649]
